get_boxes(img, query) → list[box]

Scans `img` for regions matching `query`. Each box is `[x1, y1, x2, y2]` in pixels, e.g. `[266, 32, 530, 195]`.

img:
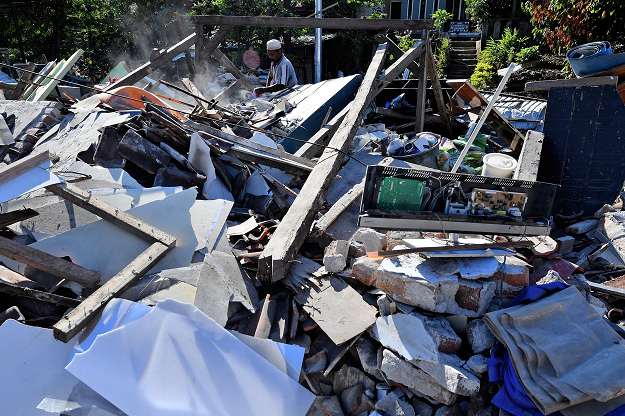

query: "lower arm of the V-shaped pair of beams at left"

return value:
[54, 243, 171, 342]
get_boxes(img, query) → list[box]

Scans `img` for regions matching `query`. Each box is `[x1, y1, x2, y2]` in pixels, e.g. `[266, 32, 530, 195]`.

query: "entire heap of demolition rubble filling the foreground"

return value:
[0, 20, 625, 416]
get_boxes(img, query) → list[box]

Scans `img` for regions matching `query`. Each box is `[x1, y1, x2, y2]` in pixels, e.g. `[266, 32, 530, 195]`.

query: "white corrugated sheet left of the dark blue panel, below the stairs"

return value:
[480, 91, 547, 132]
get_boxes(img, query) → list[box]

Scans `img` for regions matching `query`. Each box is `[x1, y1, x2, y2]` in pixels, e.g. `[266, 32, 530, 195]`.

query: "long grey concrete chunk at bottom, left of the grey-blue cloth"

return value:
[380, 349, 458, 405]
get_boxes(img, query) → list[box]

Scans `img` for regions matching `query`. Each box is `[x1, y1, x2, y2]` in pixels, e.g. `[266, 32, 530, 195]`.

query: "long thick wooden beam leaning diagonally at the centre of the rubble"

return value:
[258, 45, 387, 282]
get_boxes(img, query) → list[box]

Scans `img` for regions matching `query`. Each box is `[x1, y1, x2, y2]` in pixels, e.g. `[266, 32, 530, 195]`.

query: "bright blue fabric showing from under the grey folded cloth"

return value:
[488, 282, 625, 416]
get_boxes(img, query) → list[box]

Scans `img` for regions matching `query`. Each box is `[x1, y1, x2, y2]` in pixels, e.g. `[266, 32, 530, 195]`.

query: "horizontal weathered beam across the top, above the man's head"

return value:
[192, 15, 434, 30]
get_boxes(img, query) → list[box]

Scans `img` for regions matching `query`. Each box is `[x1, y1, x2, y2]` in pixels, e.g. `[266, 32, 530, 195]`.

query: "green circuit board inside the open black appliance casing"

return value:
[376, 177, 425, 211]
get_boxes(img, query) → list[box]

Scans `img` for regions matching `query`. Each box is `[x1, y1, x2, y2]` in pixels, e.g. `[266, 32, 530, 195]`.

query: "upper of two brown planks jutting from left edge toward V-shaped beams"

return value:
[0, 237, 100, 287]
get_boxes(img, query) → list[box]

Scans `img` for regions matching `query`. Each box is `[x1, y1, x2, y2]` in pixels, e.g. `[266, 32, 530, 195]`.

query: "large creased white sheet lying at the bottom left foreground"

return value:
[66, 299, 315, 416]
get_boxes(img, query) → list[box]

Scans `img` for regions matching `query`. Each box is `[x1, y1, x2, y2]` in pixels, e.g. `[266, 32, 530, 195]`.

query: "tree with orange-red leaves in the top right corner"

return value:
[523, 0, 625, 51]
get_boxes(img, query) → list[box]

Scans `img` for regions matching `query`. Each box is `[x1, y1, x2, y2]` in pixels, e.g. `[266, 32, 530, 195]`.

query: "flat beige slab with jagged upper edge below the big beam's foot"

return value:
[284, 256, 376, 344]
